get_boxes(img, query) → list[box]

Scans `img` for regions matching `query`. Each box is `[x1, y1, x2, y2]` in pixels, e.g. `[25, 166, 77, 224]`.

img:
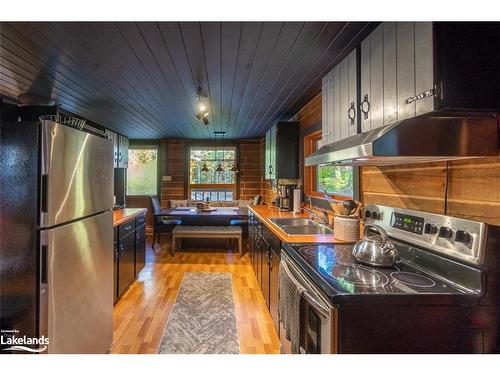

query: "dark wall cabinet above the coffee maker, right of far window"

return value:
[264, 122, 300, 180]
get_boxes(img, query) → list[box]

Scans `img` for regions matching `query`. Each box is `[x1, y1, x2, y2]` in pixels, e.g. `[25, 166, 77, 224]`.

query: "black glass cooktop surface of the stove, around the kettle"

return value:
[284, 242, 481, 303]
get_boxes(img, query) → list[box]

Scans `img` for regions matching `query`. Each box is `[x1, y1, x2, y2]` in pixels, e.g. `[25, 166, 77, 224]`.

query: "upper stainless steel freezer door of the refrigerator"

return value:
[40, 121, 113, 227]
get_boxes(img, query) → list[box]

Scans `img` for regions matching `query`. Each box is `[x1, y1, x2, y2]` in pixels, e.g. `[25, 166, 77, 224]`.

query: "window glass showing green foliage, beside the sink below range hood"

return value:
[317, 165, 353, 196]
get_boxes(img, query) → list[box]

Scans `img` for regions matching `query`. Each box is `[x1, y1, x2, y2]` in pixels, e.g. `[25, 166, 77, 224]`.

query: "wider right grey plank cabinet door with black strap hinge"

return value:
[360, 22, 434, 132]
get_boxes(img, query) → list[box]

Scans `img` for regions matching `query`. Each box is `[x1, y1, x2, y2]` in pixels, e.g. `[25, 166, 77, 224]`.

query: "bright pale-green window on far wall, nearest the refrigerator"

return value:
[127, 148, 158, 195]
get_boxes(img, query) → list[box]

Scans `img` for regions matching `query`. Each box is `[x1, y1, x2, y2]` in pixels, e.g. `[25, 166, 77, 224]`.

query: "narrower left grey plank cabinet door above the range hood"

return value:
[321, 49, 358, 144]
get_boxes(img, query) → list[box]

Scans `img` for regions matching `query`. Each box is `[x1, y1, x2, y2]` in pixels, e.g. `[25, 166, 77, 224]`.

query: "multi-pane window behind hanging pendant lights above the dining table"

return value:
[189, 146, 236, 201]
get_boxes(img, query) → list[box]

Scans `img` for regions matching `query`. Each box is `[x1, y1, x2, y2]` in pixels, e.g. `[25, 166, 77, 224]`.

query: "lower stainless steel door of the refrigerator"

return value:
[40, 211, 113, 353]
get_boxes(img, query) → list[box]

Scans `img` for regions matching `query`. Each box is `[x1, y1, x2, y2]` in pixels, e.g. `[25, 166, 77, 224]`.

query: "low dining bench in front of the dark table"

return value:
[171, 225, 243, 256]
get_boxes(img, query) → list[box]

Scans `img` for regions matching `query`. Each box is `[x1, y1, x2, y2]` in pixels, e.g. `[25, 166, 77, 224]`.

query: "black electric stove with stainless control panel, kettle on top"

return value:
[280, 205, 500, 353]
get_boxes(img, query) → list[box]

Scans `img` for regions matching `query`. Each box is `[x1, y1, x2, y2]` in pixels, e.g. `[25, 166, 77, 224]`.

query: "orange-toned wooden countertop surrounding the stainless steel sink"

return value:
[248, 205, 356, 243]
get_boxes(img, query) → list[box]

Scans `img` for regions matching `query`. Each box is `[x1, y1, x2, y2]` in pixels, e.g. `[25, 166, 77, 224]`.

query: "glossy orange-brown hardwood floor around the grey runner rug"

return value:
[111, 236, 279, 354]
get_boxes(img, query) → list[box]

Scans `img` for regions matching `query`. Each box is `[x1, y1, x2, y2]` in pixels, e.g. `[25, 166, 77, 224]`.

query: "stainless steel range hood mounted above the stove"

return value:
[305, 114, 498, 166]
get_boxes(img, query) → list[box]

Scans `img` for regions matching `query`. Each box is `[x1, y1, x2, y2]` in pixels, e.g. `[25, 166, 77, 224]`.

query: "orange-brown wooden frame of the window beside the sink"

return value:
[304, 130, 359, 200]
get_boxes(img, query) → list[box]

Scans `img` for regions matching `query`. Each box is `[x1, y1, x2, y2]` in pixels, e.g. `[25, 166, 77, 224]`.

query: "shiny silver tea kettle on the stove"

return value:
[352, 224, 399, 267]
